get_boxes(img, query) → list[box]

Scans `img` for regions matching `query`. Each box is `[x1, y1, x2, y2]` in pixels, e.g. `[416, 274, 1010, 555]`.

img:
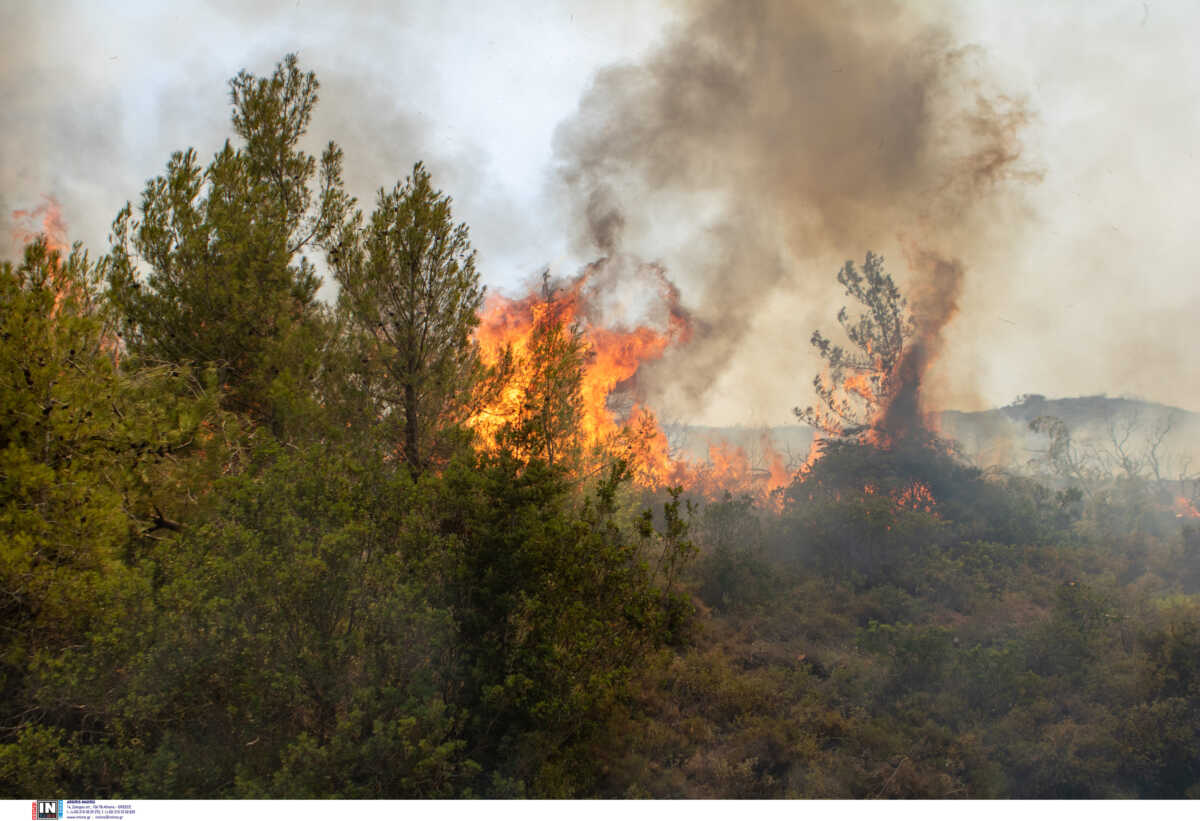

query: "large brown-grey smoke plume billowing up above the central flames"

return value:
[556, 0, 1030, 417]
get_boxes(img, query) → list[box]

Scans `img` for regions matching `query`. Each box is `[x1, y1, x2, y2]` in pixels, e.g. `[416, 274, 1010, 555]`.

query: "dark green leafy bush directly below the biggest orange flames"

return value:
[443, 453, 691, 796]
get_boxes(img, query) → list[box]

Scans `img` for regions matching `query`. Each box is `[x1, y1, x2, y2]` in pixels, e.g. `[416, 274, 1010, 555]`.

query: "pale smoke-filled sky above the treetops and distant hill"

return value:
[0, 0, 1200, 425]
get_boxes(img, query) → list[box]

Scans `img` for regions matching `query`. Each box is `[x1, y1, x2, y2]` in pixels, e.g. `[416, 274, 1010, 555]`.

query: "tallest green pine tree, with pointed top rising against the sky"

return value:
[108, 55, 353, 432]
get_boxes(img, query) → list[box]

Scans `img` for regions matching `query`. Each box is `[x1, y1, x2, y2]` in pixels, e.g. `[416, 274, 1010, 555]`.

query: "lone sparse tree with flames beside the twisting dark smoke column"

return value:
[794, 251, 916, 442]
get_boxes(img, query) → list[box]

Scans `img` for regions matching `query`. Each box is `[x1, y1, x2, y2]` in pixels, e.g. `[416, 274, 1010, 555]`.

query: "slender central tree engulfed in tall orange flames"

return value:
[469, 259, 689, 485]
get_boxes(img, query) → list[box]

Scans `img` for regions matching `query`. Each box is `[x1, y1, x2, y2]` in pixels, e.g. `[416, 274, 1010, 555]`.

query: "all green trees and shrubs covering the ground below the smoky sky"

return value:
[0, 58, 1200, 798]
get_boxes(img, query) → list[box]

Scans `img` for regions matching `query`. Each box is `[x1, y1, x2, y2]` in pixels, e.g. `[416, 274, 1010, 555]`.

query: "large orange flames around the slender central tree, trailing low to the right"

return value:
[468, 258, 793, 498]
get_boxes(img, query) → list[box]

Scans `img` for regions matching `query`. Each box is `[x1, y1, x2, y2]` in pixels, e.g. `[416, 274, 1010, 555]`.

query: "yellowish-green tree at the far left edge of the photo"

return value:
[0, 240, 224, 792]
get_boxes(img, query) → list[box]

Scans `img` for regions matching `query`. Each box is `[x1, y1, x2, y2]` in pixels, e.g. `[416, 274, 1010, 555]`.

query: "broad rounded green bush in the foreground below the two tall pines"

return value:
[113, 448, 470, 797]
